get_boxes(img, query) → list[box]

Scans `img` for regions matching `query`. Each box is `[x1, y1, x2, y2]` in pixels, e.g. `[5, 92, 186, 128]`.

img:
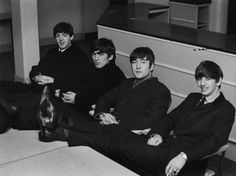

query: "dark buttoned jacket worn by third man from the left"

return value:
[95, 78, 171, 130]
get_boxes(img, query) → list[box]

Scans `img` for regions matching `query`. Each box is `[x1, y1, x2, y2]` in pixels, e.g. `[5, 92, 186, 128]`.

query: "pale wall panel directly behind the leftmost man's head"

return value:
[38, 0, 82, 38]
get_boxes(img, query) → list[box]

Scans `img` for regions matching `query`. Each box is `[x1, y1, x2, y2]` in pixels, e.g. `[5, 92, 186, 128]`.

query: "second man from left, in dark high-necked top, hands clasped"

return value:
[51, 38, 126, 114]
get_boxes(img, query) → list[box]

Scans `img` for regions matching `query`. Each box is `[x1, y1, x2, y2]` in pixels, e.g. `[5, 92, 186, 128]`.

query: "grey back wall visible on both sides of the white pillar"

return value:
[0, 0, 109, 51]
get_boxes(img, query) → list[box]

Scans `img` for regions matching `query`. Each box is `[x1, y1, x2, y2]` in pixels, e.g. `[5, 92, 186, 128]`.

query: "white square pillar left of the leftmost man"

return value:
[11, 0, 39, 82]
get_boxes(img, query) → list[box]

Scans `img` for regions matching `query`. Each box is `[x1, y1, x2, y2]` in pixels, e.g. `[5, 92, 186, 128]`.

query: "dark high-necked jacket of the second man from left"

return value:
[67, 62, 126, 114]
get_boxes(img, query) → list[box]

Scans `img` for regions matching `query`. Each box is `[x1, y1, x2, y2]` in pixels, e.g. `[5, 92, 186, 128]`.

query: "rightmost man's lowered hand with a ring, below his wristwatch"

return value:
[165, 153, 187, 176]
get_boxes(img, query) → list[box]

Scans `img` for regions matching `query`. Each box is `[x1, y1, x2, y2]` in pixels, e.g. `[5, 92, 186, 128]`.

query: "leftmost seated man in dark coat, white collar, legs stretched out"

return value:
[0, 22, 89, 133]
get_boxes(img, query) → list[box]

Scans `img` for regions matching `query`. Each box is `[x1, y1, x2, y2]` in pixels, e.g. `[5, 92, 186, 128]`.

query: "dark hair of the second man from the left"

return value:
[90, 38, 116, 61]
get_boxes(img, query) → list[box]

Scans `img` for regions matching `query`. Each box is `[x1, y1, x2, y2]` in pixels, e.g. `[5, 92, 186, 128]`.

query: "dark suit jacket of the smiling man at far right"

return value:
[149, 93, 235, 162]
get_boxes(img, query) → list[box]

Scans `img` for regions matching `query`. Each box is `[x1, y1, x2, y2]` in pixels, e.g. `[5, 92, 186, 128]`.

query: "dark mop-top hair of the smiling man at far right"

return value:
[195, 60, 223, 82]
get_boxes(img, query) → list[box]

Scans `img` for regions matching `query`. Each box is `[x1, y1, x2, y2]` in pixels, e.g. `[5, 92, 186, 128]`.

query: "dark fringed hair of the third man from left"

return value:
[129, 47, 155, 64]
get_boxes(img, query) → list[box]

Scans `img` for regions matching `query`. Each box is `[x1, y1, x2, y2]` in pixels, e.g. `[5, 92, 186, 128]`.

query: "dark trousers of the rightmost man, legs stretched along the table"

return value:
[64, 114, 206, 176]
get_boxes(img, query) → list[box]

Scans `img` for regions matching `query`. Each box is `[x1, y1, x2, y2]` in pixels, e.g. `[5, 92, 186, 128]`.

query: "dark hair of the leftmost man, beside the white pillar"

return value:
[53, 22, 74, 38]
